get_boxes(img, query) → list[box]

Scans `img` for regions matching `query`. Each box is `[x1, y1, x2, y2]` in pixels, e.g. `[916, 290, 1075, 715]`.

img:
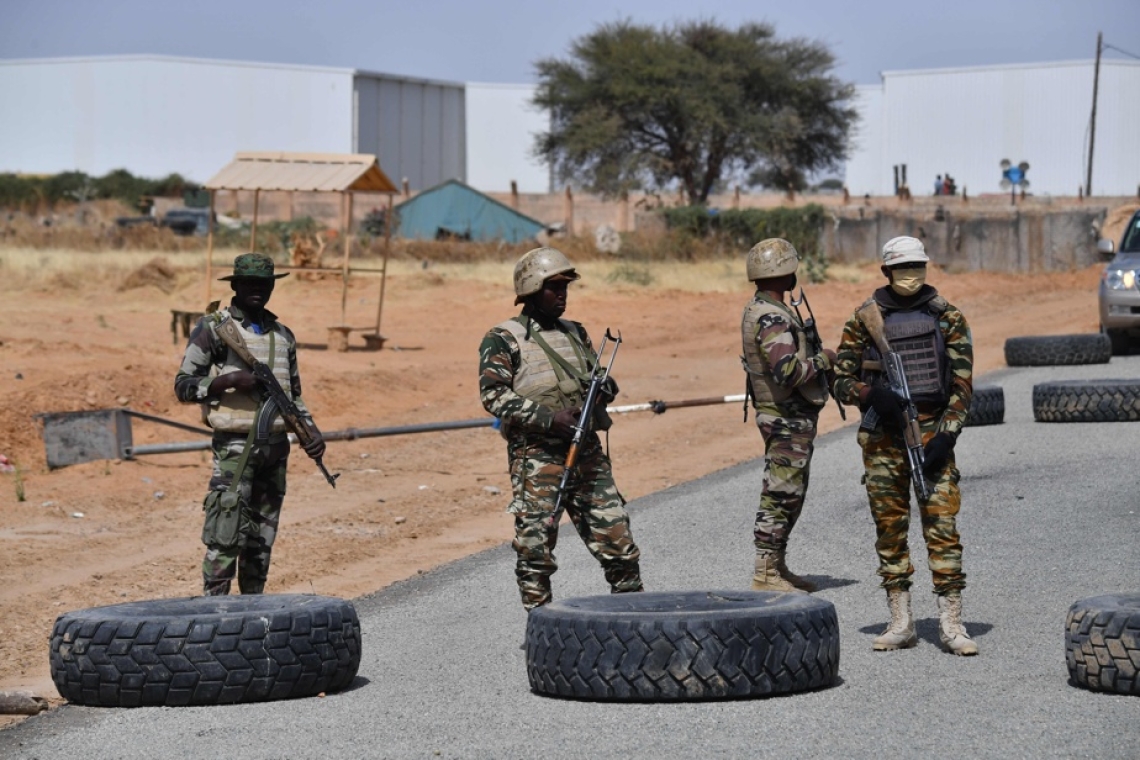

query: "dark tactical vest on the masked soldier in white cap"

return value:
[864, 300, 950, 406]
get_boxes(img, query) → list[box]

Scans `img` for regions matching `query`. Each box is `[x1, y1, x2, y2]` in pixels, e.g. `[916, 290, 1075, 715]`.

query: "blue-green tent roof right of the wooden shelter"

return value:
[394, 179, 546, 243]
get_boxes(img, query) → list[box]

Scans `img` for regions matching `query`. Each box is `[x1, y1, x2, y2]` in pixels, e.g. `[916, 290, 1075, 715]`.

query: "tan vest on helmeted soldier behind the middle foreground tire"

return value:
[497, 319, 591, 411]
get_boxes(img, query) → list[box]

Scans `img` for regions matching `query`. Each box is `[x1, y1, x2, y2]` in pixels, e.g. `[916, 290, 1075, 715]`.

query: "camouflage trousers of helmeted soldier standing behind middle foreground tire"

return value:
[507, 435, 642, 610]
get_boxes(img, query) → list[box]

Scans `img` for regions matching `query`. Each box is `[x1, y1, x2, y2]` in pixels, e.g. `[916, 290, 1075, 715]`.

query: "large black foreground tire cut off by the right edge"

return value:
[1065, 594, 1140, 695]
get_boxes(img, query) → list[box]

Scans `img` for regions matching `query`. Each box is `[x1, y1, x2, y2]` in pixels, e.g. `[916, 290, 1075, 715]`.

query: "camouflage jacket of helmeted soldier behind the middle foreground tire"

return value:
[479, 309, 594, 434]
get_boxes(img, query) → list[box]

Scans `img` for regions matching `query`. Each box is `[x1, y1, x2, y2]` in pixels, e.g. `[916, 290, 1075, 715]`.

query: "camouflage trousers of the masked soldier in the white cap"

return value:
[858, 415, 966, 595]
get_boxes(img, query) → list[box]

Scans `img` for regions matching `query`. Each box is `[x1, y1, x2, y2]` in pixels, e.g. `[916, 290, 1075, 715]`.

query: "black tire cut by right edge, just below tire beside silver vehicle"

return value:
[1033, 379, 1140, 423]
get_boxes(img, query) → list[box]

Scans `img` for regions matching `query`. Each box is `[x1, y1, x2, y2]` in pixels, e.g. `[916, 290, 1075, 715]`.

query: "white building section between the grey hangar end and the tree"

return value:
[467, 82, 553, 193]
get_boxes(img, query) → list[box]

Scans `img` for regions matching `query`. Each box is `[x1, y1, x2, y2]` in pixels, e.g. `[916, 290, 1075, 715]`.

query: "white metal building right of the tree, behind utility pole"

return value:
[846, 59, 1140, 196]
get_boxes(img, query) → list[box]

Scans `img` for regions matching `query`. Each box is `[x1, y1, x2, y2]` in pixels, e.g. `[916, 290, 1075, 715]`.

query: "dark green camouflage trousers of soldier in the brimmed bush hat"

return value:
[202, 433, 290, 596]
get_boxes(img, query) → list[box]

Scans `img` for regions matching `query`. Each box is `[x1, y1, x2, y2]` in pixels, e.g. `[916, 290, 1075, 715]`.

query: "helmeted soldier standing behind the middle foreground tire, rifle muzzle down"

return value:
[479, 247, 642, 611]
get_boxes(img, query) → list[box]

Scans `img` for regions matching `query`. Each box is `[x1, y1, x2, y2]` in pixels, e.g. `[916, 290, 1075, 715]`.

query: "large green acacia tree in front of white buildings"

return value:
[534, 21, 856, 204]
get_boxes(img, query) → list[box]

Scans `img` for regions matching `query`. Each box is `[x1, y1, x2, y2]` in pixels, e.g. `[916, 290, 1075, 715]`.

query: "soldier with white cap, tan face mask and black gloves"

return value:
[834, 237, 978, 655]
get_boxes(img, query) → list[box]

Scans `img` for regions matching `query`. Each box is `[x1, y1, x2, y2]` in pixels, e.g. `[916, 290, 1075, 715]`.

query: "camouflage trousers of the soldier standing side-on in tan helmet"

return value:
[752, 408, 820, 551]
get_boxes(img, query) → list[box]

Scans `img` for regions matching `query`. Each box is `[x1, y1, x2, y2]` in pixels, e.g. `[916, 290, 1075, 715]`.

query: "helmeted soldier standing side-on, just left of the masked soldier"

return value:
[740, 238, 836, 591]
